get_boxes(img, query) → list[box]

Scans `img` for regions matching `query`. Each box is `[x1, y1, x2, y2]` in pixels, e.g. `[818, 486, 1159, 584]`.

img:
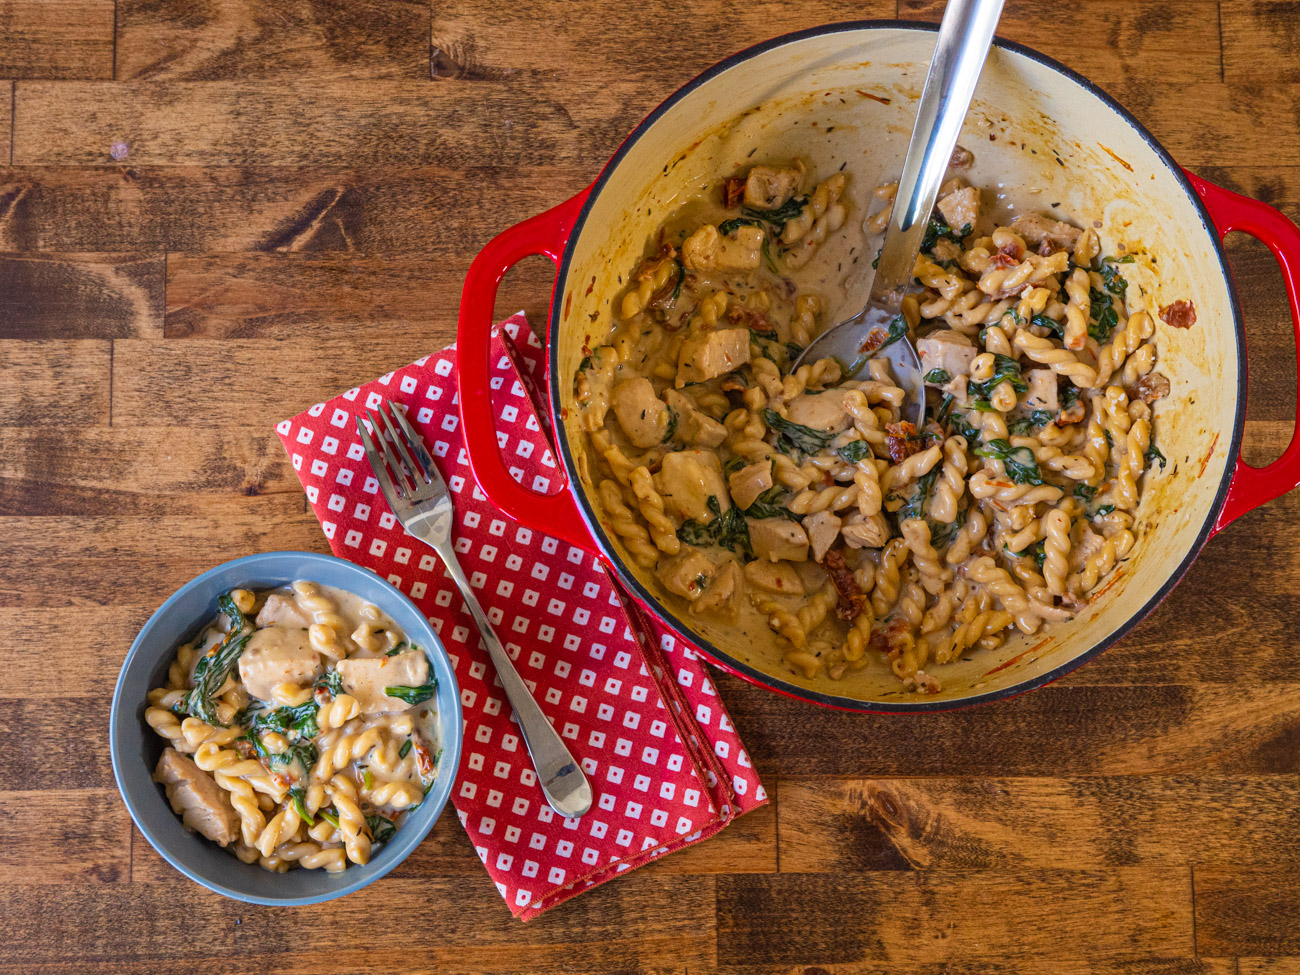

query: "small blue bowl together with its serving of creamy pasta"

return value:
[111, 553, 462, 904]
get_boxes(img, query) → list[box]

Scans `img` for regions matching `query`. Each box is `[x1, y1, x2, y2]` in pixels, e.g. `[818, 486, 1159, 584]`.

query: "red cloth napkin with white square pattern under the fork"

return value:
[276, 315, 767, 920]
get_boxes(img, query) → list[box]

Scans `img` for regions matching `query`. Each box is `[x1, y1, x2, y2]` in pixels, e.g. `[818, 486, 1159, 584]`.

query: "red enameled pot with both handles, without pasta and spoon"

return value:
[458, 22, 1300, 711]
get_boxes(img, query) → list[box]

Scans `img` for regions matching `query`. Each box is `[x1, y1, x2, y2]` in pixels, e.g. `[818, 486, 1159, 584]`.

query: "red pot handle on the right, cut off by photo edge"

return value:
[1183, 169, 1300, 534]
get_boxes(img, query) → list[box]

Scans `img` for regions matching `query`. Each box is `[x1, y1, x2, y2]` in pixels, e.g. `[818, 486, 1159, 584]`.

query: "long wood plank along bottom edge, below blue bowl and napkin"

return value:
[0, 873, 714, 972]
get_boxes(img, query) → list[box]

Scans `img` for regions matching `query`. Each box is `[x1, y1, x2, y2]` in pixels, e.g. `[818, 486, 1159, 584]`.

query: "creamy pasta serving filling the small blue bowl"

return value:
[144, 581, 441, 872]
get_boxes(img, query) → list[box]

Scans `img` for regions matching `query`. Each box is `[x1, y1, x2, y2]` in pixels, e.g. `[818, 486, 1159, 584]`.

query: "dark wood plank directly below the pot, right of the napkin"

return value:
[719, 681, 1300, 776]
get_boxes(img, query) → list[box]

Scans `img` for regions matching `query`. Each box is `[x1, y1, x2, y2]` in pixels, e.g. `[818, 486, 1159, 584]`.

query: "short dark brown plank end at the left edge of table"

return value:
[0, 254, 166, 339]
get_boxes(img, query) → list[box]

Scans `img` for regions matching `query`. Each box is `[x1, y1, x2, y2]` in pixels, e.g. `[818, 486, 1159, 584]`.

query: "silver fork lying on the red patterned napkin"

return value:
[355, 400, 592, 818]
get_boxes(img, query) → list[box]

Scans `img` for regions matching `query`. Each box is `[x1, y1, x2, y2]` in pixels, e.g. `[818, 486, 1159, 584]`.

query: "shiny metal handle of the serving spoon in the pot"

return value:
[871, 0, 1002, 304]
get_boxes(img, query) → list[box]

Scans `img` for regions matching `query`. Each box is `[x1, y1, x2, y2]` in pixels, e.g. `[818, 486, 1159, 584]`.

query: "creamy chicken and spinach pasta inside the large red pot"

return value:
[576, 156, 1195, 693]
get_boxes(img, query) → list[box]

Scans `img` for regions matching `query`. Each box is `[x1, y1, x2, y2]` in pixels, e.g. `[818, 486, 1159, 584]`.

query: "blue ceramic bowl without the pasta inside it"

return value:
[109, 551, 463, 905]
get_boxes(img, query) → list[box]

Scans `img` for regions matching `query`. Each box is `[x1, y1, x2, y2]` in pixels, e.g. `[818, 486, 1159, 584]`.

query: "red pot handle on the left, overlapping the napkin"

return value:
[456, 189, 593, 550]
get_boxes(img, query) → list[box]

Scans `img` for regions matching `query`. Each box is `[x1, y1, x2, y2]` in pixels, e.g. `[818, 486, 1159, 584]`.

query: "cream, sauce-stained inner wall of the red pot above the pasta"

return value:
[551, 25, 1242, 710]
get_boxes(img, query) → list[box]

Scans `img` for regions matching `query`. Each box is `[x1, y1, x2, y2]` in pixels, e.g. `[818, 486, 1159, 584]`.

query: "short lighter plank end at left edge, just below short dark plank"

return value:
[0, 339, 112, 426]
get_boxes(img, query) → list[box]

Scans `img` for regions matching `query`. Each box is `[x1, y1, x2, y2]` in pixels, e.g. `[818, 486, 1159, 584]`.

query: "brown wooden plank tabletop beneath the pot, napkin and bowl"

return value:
[0, 0, 1300, 975]
